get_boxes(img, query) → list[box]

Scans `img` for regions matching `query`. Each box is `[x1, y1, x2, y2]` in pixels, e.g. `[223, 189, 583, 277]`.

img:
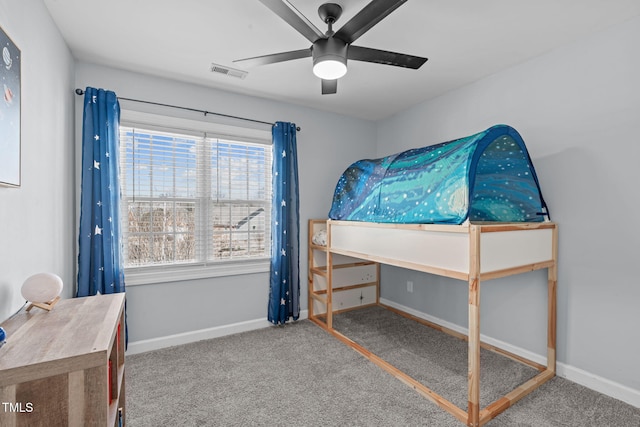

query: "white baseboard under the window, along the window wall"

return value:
[127, 310, 309, 356]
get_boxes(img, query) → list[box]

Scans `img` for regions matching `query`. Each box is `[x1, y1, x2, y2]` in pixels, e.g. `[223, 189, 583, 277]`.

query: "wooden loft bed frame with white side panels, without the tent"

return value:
[309, 220, 558, 427]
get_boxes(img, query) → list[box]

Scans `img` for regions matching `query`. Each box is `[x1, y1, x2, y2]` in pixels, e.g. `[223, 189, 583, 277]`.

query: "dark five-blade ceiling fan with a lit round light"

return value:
[233, 0, 427, 95]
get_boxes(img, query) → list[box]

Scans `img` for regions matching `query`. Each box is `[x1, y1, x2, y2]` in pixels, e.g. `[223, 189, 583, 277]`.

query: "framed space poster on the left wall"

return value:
[0, 28, 21, 187]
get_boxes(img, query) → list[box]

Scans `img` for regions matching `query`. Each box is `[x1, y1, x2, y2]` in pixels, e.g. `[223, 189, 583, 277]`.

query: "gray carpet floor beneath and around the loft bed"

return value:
[126, 307, 640, 427]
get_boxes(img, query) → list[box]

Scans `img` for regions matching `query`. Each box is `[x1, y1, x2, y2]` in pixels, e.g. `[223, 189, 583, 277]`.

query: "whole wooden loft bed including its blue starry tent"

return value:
[308, 125, 558, 427]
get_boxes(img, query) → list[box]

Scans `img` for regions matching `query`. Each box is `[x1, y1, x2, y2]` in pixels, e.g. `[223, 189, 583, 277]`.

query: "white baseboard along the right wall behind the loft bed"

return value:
[380, 298, 640, 408]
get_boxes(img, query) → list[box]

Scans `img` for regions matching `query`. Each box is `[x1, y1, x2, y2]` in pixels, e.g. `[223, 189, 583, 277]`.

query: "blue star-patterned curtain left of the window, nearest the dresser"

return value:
[76, 87, 125, 297]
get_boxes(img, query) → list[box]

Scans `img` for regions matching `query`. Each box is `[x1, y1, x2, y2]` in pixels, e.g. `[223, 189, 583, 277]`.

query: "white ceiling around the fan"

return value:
[44, 0, 640, 120]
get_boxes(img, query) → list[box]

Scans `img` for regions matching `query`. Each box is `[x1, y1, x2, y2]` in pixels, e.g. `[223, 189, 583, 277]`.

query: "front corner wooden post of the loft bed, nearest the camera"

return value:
[467, 225, 480, 427]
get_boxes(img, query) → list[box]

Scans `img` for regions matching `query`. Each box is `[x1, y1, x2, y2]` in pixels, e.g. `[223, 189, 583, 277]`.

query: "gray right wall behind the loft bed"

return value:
[378, 14, 640, 390]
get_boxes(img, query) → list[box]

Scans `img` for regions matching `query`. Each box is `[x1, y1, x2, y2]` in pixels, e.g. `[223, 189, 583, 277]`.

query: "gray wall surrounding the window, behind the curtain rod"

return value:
[76, 63, 376, 341]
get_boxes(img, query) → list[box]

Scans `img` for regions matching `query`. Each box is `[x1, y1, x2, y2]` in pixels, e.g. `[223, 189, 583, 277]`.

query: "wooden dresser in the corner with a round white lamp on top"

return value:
[0, 294, 126, 427]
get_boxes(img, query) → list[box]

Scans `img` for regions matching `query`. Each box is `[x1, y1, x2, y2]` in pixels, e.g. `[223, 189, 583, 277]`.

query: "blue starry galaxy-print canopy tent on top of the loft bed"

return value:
[329, 125, 549, 224]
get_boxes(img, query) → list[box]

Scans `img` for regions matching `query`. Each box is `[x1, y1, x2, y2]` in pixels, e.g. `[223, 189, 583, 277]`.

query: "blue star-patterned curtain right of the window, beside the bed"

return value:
[268, 122, 300, 325]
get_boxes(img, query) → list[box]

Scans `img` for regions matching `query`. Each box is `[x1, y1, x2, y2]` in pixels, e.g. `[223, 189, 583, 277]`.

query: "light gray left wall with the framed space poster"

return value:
[0, 0, 76, 321]
